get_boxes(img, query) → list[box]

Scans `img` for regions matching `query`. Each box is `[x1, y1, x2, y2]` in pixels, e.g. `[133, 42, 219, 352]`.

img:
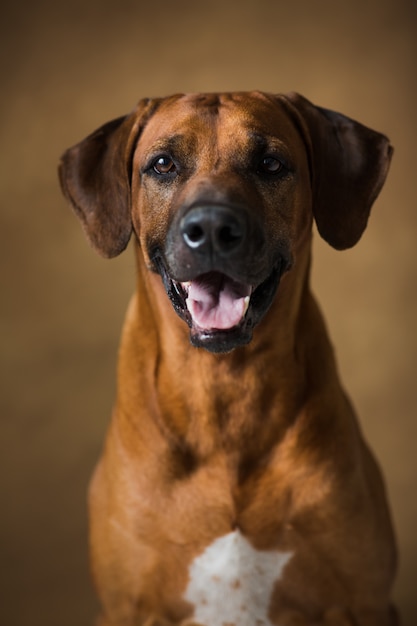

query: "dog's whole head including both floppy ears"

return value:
[60, 92, 392, 352]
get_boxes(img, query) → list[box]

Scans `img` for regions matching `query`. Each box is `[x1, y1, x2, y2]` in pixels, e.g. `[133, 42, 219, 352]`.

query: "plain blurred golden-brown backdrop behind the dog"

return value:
[0, 0, 417, 626]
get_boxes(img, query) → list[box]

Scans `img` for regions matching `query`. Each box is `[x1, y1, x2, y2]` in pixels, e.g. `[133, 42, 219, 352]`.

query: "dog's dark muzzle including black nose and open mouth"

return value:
[152, 204, 289, 352]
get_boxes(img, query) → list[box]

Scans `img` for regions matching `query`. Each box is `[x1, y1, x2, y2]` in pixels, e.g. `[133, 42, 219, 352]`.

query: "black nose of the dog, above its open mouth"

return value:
[180, 205, 247, 256]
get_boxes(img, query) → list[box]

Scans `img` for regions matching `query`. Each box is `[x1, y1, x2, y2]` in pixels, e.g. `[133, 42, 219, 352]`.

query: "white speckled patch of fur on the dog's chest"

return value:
[185, 531, 292, 626]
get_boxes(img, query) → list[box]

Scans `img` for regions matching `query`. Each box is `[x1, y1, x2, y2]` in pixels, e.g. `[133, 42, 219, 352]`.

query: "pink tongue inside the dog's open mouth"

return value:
[186, 272, 251, 330]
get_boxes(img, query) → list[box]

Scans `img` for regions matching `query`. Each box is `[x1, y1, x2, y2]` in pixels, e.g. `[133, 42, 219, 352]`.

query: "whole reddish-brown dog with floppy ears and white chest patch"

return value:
[60, 92, 397, 626]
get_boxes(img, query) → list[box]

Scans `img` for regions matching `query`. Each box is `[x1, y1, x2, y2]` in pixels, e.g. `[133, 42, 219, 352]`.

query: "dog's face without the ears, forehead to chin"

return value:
[132, 94, 312, 352]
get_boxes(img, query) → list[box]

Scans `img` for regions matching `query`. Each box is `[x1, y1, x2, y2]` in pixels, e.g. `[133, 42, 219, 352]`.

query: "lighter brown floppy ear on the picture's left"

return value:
[59, 100, 156, 258]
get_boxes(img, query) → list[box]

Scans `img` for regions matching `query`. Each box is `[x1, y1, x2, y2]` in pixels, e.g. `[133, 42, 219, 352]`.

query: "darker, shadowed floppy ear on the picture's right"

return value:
[284, 93, 393, 250]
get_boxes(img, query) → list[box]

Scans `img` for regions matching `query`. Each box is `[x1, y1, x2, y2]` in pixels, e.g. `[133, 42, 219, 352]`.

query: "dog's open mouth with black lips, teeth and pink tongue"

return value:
[154, 255, 284, 353]
